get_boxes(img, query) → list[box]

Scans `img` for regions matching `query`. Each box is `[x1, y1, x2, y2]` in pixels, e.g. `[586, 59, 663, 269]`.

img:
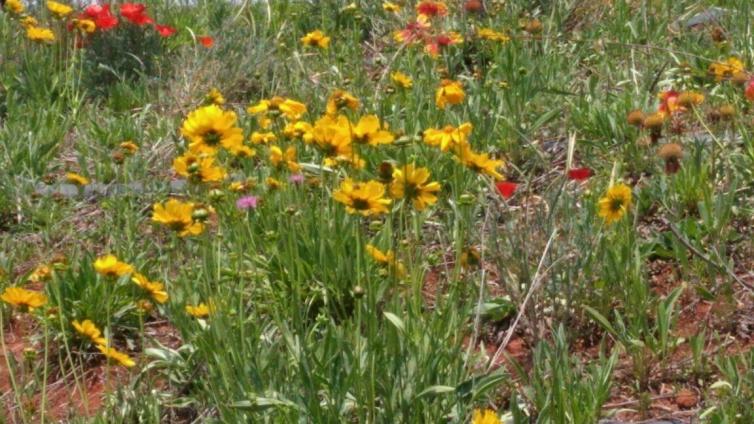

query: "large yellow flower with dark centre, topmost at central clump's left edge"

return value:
[181, 105, 243, 154]
